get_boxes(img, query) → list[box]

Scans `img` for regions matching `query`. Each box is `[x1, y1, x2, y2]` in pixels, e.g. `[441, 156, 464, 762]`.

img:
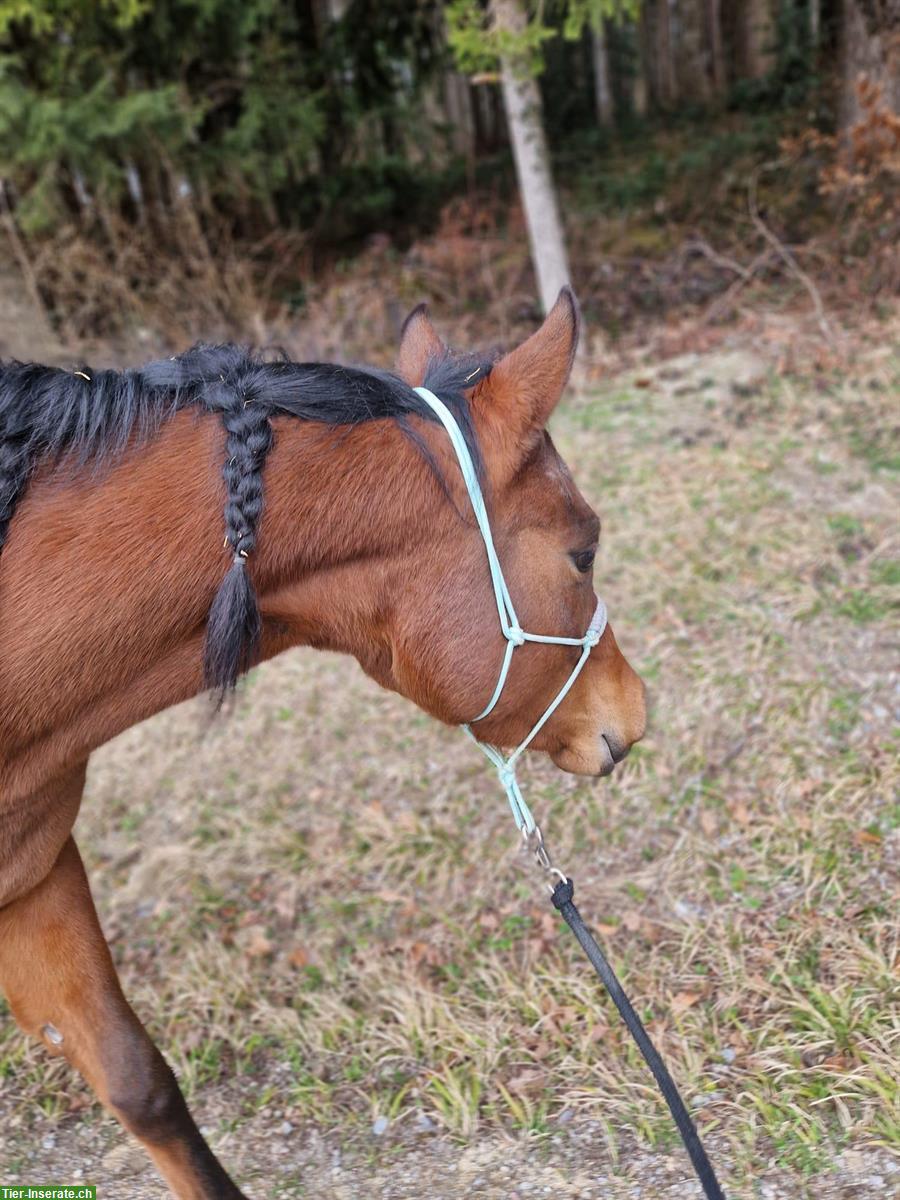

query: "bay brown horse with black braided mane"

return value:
[0, 292, 644, 1200]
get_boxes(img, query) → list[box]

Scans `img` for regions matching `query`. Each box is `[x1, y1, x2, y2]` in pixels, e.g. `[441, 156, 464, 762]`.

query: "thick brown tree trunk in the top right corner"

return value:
[840, 0, 900, 128]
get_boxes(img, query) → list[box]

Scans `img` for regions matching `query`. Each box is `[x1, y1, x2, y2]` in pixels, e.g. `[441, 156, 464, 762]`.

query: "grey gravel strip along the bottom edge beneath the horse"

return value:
[0, 1092, 900, 1200]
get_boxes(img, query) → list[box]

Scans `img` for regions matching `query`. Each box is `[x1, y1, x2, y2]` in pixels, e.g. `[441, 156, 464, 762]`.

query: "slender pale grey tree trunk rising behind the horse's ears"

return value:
[491, 0, 569, 312]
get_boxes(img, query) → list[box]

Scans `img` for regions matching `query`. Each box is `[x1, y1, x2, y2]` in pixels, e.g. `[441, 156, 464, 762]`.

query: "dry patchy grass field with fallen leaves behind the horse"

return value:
[0, 333, 900, 1198]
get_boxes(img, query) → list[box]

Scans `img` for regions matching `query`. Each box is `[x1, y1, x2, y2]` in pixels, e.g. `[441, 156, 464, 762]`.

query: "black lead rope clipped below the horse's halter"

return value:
[553, 878, 725, 1200]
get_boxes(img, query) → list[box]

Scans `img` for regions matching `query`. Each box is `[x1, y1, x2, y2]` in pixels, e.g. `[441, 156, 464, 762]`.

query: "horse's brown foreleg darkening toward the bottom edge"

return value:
[0, 838, 245, 1200]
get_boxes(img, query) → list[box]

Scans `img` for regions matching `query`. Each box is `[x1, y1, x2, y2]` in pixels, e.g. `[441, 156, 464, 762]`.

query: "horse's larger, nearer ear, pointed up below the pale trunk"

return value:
[472, 287, 581, 475]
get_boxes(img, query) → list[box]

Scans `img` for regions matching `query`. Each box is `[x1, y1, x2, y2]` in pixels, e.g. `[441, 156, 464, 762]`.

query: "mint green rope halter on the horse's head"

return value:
[414, 388, 606, 835]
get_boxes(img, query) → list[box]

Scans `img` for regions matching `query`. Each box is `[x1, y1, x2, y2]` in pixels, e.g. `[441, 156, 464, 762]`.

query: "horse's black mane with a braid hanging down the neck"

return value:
[0, 344, 491, 701]
